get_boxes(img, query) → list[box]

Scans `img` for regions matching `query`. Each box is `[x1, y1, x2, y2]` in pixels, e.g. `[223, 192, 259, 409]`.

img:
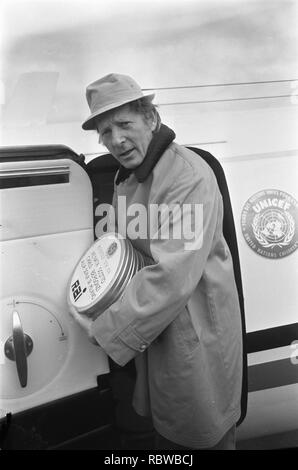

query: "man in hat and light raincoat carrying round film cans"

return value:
[72, 74, 242, 449]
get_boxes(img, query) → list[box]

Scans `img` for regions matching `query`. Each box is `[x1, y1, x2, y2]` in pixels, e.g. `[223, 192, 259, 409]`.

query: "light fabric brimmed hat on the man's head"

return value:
[82, 73, 155, 131]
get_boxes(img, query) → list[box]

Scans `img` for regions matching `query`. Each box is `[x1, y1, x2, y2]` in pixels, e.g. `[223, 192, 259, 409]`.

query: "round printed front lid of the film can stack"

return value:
[70, 236, 122, 311]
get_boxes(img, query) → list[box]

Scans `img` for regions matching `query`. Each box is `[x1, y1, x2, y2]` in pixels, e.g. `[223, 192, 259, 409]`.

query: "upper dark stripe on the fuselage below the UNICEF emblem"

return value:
[246, 323, 298, 354]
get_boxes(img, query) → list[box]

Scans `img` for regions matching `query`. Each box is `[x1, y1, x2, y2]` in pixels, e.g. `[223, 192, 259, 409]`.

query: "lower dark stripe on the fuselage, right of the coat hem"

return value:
[248, 357, 298, 392]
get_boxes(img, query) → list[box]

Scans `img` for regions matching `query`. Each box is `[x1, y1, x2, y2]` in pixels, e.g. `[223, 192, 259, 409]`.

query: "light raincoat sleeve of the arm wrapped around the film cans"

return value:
[91, 156, 222, 365]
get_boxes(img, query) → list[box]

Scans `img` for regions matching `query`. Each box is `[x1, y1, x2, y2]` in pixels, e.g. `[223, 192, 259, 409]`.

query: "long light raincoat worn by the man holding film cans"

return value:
[91, 142, 242, 448]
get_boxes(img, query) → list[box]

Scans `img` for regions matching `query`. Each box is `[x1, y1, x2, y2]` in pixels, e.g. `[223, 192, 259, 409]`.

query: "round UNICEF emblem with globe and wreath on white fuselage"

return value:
[241, 189, 298, 259]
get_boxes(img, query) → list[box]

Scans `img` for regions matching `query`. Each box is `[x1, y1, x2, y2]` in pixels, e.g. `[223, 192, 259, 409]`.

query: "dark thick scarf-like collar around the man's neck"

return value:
[116, 124, 176, 185]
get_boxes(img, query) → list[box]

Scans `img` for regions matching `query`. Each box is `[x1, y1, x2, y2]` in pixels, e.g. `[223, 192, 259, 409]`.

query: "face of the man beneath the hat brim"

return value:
[96, 104, 156, 169]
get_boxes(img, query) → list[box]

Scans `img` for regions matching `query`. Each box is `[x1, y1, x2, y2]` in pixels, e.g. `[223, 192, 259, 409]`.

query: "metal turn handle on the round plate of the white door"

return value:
[4, 310, 33, 387]
